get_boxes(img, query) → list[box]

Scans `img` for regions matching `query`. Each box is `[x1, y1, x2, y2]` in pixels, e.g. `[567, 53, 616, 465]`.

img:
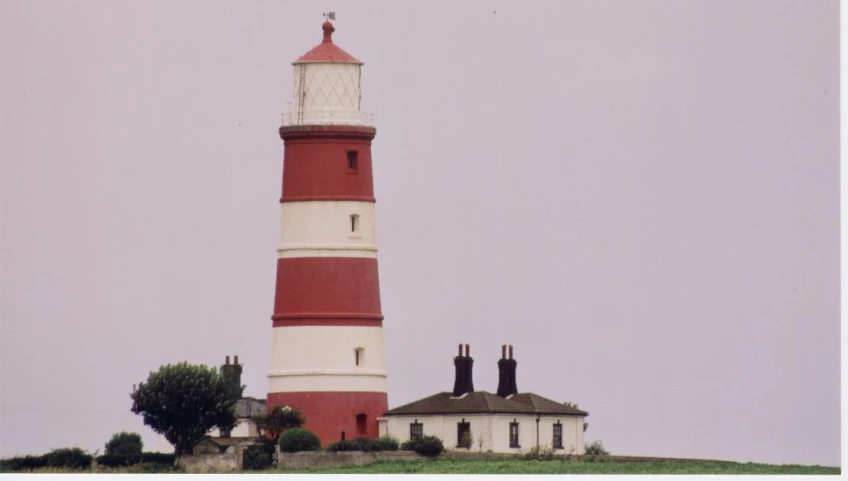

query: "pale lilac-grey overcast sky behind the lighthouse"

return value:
[0, 0, 840, 465]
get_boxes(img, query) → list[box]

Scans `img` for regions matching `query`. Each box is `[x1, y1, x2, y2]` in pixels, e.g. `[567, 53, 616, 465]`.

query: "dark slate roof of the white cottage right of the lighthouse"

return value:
[386, 391, 589, 416]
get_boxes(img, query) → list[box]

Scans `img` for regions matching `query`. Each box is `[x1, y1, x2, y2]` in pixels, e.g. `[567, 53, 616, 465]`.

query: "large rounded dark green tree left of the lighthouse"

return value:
[130, 362, 244, 456]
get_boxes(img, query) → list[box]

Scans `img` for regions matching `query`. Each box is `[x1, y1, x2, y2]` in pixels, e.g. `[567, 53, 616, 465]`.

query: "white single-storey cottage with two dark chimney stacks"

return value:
[378, 344, 589, 454]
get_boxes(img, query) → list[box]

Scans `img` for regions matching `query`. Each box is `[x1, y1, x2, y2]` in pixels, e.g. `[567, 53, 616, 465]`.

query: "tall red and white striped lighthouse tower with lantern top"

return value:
[268, 21, 388, 445]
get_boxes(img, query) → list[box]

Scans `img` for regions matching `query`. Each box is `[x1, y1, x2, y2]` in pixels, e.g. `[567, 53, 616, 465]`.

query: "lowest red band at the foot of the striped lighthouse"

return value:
[267, 392, 389, 447]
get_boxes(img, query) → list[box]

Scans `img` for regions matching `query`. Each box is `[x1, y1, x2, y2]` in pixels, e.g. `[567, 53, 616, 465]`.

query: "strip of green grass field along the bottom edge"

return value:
[274, 459, 841, 474]
